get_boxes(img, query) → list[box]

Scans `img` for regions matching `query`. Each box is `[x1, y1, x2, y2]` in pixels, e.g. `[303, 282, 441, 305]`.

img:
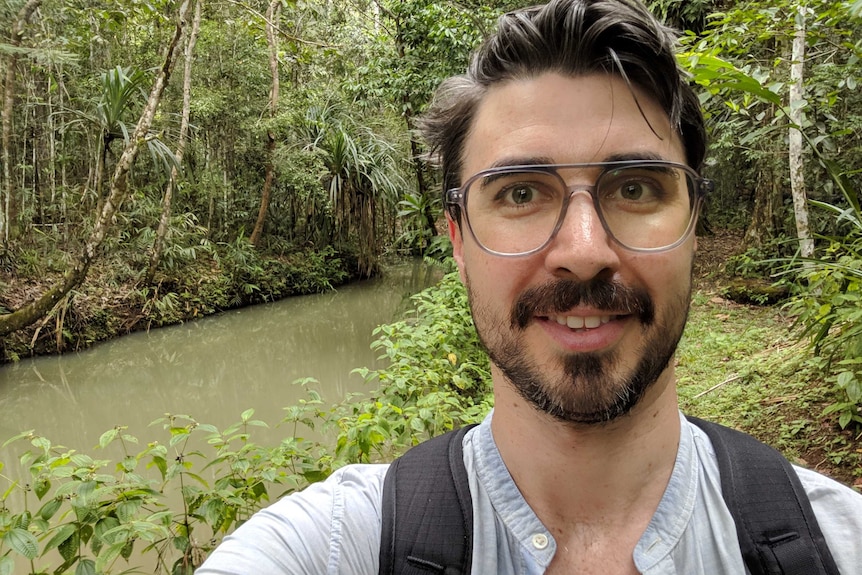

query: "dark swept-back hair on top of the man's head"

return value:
[419, 0, 706, 217]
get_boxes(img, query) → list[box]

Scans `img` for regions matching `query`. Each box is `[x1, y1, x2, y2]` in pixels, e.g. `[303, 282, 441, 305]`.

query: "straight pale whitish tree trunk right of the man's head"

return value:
[788, 6, 814, 258]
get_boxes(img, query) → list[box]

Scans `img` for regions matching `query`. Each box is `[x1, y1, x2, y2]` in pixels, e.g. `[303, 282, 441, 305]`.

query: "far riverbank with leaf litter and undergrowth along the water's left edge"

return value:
[0, 244, 357, 364]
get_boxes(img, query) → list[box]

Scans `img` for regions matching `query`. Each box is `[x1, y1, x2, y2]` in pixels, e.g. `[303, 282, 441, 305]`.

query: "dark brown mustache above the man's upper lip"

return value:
[510, 278, 655, 329]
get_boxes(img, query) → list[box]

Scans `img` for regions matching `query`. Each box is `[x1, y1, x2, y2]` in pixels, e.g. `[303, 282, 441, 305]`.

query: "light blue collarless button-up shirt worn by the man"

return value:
[196, 415, 862, 575]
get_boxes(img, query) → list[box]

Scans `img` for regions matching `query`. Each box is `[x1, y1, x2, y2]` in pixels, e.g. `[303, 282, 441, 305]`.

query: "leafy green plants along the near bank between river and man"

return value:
[0, 273, 490, 575]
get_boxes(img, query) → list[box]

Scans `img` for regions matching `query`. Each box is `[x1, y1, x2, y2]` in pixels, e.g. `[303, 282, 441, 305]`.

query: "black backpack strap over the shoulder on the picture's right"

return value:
[688, 417, 838, 575]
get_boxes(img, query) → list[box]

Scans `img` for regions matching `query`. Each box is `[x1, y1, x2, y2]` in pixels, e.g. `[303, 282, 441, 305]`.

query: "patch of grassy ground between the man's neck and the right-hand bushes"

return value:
[676, 293, 862, 474]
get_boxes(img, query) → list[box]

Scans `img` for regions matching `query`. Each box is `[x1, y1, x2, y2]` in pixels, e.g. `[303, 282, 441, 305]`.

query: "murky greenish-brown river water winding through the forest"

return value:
[0, 264, 439, 454]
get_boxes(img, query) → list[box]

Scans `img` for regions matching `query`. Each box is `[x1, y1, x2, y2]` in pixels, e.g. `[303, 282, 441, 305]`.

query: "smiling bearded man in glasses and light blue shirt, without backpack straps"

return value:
[198, 0, 862, 575]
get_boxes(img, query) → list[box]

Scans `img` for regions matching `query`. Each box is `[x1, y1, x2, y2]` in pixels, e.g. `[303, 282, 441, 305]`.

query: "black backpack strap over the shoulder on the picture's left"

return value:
[379, 426, 480, 575]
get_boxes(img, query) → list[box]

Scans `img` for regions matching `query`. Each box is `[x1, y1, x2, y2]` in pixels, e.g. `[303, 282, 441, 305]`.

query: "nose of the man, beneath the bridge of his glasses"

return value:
[545, 190, 619, 281]
